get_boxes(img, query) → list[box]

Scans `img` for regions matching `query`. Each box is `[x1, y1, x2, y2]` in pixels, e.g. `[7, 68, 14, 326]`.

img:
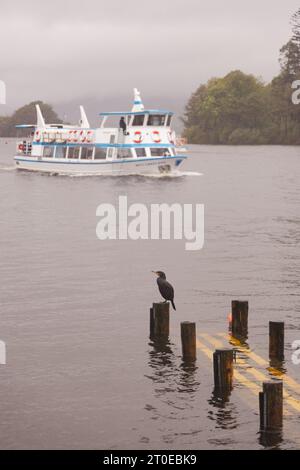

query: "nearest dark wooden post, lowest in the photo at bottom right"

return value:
[259, 380, 283, 432]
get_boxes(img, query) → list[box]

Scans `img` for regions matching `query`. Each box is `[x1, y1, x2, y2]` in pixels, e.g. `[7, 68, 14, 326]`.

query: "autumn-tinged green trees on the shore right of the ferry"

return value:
[182, 8, 300, 145]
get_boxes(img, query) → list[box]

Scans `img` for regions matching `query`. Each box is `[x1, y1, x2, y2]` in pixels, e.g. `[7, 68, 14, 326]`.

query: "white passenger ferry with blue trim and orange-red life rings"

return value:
[14, 89, 187, 175]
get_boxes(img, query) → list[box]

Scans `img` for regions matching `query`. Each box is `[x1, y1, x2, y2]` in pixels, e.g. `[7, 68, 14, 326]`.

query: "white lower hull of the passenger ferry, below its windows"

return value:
[15, 155, 187, 175]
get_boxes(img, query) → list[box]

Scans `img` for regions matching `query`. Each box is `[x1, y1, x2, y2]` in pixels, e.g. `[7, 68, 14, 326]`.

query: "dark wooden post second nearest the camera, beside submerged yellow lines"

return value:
[213, 349, 233, 392]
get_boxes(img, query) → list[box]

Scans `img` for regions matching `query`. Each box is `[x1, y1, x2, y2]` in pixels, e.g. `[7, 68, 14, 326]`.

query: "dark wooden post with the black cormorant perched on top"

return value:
[150, 302, 170, 339]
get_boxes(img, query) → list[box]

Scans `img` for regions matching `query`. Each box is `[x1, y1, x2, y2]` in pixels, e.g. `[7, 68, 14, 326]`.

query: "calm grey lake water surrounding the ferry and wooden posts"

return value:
[0, 139, 300, 449]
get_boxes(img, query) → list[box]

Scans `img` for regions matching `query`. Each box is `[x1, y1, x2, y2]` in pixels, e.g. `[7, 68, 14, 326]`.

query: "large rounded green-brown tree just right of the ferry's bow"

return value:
[183, 70, 267, 144]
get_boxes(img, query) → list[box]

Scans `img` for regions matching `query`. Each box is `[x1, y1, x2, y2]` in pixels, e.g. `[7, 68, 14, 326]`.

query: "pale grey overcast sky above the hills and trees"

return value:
[0, 0, 300, 114]
